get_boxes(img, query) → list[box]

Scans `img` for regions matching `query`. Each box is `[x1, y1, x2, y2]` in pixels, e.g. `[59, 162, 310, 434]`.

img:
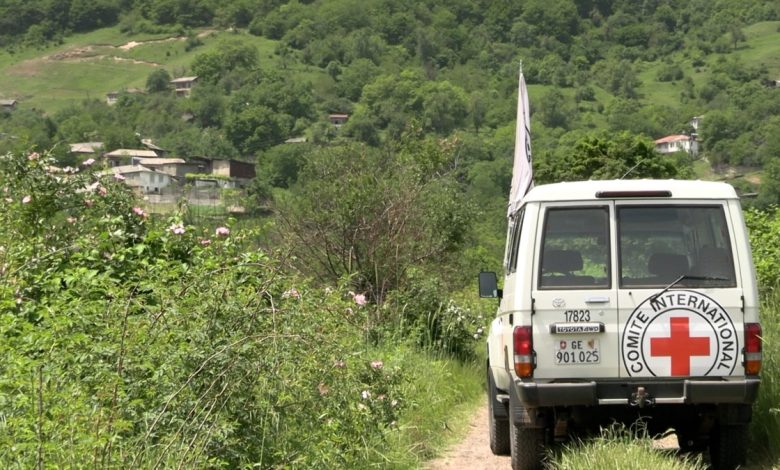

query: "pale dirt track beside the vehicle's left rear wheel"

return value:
[426, 405, 512, 470]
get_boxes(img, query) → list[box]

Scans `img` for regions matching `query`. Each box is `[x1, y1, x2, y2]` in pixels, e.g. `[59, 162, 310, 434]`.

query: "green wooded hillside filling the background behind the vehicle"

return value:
[0, 0, 780, 215]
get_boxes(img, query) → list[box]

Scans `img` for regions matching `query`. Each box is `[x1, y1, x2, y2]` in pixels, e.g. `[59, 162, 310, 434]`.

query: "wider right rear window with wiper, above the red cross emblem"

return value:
[617, 206, 736, 288]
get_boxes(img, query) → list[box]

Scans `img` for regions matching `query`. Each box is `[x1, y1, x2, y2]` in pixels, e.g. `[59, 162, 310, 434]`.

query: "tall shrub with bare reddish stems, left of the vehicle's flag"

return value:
[278, 130, 469, 302]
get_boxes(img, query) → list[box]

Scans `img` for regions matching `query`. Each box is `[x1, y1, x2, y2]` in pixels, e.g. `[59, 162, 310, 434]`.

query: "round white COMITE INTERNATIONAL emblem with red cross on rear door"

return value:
[620, 290, 740, 377]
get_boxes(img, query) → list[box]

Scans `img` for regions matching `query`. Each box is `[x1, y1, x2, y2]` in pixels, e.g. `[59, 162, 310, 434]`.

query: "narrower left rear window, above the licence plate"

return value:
[539, 206, 611, 289]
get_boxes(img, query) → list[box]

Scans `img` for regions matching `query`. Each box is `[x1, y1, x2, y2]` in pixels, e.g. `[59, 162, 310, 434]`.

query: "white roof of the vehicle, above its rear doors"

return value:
[523, 179, 738, 202]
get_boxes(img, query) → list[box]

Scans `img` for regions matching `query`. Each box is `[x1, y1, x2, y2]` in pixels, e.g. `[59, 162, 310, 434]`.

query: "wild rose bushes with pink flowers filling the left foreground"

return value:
[0, 154, 478, 468]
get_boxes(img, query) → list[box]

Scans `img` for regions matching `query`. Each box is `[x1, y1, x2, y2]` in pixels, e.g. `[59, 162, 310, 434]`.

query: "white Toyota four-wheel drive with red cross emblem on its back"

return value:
[480, 180, 761, 469]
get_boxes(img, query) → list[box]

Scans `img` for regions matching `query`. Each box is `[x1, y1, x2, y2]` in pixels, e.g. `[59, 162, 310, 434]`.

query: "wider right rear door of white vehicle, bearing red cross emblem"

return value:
[615, 201, 743, 377]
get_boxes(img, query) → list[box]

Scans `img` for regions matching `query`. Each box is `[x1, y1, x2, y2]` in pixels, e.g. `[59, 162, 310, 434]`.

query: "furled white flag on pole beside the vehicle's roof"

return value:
[507, 69, 533, 215]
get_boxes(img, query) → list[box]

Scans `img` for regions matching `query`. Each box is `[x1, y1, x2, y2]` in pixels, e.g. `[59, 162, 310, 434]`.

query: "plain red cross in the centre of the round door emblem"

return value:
[650, 317, 710, 375]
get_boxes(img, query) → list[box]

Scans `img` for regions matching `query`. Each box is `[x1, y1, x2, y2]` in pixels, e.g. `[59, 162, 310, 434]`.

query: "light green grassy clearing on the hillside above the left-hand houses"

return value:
[0, 27, 296, 113]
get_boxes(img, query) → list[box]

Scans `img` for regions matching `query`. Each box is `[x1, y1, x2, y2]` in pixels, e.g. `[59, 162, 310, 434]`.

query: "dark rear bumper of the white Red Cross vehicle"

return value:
[515, 377, 761, 408]
